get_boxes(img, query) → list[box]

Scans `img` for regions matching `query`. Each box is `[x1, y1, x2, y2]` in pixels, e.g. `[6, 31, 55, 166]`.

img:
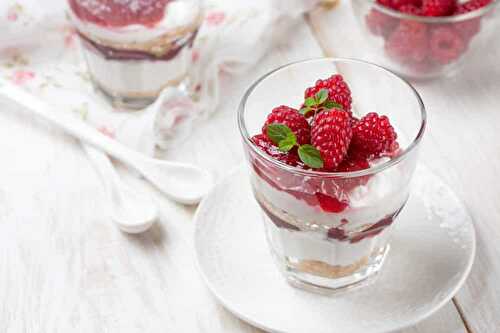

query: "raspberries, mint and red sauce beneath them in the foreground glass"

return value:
[251, 74, 399, 212]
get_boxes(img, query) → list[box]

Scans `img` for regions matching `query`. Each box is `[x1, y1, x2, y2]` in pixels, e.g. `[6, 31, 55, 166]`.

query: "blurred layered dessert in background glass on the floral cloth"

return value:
[68, 0, 202, 108]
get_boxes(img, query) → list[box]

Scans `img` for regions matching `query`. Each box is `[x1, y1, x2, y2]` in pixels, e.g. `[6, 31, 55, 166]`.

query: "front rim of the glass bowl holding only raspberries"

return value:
[366, 0, 500, 24]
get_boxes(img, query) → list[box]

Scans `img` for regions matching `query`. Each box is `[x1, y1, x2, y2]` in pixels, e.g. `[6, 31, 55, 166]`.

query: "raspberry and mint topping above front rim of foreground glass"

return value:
[252, 74, 398, 172]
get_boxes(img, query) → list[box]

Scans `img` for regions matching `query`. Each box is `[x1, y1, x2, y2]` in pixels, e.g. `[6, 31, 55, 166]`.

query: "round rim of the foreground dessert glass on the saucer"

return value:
[238, 57, 427, 179]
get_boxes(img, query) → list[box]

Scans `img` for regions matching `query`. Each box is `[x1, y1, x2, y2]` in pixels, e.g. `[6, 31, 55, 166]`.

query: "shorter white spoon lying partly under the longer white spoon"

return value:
[82, 144, 158, 234]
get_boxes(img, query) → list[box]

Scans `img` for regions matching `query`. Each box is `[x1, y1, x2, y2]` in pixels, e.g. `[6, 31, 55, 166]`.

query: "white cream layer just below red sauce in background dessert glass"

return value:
[69, 0, 202, 44]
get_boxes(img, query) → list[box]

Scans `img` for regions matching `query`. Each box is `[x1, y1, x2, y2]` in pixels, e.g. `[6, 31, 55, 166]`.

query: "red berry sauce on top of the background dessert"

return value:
[69, 0, 171, 28]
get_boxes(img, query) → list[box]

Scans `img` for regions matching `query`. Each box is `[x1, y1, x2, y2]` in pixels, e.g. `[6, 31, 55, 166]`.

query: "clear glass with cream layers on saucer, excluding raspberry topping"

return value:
[238, 59, 426, 292]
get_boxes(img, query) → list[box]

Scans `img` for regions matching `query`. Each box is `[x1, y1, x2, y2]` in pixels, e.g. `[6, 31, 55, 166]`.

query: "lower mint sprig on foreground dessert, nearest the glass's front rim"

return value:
[266, 124, 324, 169]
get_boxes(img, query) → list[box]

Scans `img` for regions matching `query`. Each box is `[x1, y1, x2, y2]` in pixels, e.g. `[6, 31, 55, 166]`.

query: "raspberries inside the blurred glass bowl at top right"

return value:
[365, 0, 493, 74]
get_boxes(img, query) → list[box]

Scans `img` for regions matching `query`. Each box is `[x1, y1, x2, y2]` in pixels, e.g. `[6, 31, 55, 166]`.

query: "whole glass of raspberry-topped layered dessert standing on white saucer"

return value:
[238, 59, 426, 292]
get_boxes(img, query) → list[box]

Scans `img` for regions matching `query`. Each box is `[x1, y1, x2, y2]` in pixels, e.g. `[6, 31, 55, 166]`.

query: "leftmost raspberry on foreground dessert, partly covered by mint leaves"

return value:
[262, 105, 311, 145]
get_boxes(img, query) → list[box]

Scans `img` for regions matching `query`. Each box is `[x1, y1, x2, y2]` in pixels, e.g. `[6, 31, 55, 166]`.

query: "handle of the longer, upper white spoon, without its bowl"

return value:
[0, 79, 145, 166]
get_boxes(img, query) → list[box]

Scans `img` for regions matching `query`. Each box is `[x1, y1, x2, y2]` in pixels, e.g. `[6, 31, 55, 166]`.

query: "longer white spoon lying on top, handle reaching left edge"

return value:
[0, 79, 213, 204]
